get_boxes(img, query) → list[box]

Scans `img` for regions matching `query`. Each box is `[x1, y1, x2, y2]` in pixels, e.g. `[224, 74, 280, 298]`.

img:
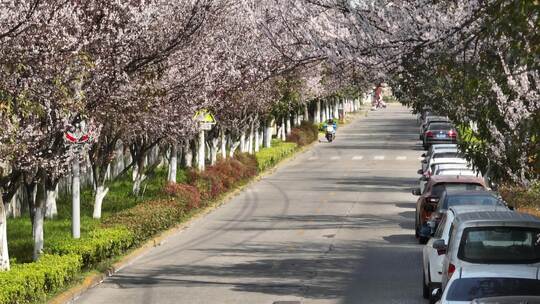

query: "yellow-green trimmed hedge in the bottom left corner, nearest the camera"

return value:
[0, 254, 82, 304]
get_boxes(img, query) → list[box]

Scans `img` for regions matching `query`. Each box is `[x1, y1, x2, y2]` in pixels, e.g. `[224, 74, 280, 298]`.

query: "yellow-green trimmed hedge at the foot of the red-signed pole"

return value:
[45, 227, 135, 268]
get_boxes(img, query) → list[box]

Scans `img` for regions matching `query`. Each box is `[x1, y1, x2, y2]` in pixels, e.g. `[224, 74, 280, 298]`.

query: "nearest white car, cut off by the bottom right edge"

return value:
[433, 265, 540, 304]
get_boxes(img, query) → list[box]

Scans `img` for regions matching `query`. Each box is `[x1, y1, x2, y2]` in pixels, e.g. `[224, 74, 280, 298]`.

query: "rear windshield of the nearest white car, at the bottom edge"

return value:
[446, 278, 540, 302]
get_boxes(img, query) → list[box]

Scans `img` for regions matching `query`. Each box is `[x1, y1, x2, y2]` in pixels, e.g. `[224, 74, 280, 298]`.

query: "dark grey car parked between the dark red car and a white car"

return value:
[419, 189, 508, 238]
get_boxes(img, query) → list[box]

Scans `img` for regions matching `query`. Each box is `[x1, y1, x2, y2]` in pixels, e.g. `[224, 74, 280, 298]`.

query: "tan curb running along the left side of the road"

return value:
[47, 109, 367, 304]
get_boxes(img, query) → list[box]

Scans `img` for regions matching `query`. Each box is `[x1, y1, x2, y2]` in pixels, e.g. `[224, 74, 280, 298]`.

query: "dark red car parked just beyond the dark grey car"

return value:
[412, 176, 487, 244]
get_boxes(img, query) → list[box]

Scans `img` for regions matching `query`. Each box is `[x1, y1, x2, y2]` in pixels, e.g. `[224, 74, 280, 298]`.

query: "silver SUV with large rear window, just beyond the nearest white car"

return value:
[433, 211, 540, 289]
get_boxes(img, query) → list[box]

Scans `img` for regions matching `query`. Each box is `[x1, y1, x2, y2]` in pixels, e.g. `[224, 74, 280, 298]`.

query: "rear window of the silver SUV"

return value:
[458, 226, 540, 264]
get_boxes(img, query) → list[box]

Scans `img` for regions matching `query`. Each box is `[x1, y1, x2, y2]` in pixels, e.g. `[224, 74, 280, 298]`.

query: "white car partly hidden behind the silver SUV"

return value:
[422, 205, 508, 299]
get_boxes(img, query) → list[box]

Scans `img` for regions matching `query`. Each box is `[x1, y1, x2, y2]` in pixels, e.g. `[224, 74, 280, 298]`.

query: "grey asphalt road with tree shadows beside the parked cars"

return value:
[77, 106, 425, 304]
